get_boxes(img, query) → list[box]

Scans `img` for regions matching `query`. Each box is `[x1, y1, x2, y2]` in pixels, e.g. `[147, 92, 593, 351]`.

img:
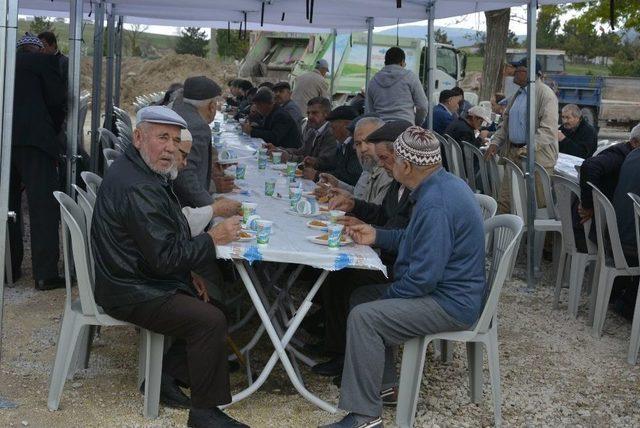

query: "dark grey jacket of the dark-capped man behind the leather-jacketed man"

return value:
[173, 100, 213, 208]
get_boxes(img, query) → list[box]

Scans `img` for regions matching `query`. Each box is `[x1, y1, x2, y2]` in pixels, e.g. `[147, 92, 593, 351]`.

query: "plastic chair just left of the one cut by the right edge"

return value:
[587, 182, 640, 337]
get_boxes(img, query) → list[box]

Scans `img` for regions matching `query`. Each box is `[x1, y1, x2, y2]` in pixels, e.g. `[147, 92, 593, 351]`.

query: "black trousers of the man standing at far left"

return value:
[9, 146, 60, 280]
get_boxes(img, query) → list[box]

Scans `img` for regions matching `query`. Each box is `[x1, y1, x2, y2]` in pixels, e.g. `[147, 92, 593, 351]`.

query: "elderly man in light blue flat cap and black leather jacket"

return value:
[91, 106, 245, 427]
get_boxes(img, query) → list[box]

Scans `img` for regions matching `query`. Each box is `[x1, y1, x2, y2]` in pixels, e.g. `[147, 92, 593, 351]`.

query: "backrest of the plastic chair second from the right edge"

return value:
[587, 182, 629, 269]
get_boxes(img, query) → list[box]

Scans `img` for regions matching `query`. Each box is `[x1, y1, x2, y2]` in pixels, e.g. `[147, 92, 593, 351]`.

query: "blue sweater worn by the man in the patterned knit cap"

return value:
[376, 168, 485, 325]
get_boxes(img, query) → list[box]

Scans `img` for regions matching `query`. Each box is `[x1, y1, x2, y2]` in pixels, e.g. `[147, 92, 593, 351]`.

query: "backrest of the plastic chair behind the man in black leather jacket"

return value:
[53, 192, 98, 316]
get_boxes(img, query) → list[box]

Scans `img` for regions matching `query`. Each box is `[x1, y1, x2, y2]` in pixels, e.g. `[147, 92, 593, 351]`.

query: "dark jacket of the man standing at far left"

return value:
[11, 53, 66, 159]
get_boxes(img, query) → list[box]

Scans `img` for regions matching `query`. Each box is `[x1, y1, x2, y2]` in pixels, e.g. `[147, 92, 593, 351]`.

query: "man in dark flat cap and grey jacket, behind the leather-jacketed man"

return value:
[173, 76, 233, 207]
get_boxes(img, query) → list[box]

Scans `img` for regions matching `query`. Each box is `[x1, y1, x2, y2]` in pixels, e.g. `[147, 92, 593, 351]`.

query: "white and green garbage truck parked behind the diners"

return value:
[239, 32, 477, 105]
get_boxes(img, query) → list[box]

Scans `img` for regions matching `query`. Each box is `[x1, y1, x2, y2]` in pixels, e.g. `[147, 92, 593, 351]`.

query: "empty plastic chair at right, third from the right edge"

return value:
[551, 175, 597, 318]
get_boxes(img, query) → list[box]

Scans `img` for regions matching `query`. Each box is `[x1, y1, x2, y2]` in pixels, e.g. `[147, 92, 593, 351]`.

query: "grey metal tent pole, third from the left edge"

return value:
[91, 2, 105, 172]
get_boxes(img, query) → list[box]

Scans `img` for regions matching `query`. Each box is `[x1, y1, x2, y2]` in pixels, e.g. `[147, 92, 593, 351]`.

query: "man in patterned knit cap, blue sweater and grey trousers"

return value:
[328, 126, 485, 428]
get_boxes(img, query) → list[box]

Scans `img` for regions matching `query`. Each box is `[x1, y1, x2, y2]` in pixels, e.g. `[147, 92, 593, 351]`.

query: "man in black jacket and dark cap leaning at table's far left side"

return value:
[242, 87, 301, 149]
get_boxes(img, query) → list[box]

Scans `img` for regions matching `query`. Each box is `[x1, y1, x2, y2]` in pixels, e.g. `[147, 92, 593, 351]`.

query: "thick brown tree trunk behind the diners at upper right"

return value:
[479, 8, 511, 100]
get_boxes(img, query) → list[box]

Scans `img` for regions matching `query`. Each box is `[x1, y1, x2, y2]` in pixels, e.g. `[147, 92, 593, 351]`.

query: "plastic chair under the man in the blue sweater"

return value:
[396, 214, 523, 427]
